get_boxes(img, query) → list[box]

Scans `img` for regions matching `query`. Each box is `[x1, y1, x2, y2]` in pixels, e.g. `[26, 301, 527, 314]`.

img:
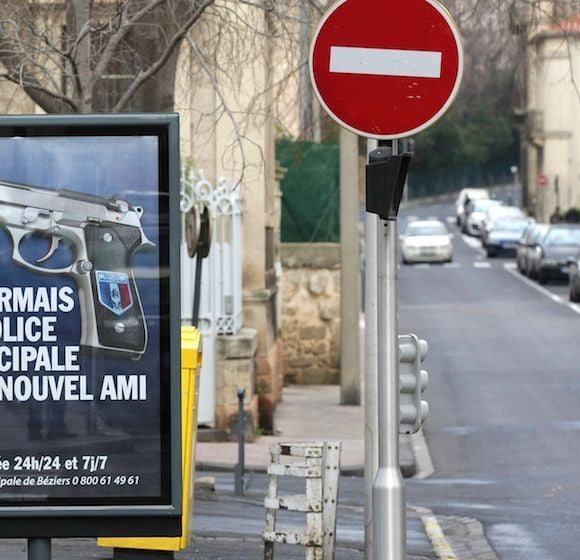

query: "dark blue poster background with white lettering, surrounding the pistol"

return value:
[0, 135, 168, 505]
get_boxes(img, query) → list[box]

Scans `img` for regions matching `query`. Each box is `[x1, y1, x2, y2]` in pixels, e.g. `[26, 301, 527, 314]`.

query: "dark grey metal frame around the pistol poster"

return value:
[0, 113, 183, 538]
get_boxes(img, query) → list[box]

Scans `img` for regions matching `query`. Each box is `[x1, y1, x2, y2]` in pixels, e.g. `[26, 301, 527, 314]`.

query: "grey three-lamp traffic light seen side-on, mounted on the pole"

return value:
[399, 334, 429, 434]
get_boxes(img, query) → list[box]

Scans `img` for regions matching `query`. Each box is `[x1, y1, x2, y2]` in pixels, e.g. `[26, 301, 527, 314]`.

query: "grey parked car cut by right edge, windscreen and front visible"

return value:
[530, 223, 580, 284]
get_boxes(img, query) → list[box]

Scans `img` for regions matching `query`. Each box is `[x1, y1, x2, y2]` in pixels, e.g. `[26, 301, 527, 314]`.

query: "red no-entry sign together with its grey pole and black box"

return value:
[309, 0, 463, 560]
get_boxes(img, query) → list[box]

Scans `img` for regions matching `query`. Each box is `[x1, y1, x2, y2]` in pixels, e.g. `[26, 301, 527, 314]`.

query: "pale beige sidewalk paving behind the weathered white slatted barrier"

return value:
[196, 385, 416, 477]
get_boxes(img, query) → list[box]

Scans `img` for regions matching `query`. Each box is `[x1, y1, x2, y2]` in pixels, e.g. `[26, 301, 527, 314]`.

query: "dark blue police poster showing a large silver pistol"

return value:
[0, 115, 179, 528]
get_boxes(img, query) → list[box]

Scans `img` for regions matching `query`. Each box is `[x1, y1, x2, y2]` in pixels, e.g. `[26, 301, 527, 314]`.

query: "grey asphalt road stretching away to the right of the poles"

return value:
[398, 200, 580, 560]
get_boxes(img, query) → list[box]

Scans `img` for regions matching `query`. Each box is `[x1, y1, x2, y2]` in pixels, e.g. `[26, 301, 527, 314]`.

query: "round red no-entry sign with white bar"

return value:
[310, 0, 463, 139]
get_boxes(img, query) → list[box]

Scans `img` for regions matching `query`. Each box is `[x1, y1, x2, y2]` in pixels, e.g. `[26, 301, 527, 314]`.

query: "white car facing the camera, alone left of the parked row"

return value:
[401, 220, 453, 264]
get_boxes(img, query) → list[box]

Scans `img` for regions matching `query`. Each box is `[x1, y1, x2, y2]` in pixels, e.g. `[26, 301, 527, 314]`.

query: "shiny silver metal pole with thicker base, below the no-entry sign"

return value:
[372, 141, 407, 560]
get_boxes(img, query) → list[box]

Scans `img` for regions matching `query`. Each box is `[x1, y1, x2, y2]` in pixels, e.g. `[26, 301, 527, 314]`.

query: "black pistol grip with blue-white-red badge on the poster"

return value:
[85, 222, 147, 354]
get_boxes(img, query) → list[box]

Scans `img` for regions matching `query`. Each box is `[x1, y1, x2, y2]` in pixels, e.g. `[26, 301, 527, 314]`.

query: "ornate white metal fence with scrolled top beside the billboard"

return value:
[181, 171, 242, 426]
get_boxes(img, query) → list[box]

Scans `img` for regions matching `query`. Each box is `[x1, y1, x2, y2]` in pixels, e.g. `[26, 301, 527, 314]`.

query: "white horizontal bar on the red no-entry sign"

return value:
[329, 47, 442, 78]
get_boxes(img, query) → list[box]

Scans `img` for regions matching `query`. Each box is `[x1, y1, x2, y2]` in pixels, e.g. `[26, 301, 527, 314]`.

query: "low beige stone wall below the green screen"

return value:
[282, 243, 340, 384]
